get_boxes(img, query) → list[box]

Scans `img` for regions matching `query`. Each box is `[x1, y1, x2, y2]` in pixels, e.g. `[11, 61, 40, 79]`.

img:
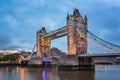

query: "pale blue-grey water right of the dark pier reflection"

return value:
[95, 65, 120, 80]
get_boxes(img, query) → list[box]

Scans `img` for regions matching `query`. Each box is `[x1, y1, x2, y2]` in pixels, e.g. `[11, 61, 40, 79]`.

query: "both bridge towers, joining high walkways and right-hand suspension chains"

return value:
[36, 8, 120, 56]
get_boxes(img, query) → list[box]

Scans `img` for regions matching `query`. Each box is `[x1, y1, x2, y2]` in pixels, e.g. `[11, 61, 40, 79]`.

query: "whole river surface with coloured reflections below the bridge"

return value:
[0, 65, 120, 80]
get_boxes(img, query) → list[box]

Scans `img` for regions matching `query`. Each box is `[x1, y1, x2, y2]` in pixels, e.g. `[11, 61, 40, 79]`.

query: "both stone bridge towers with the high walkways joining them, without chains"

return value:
[37, 9, 87, 56]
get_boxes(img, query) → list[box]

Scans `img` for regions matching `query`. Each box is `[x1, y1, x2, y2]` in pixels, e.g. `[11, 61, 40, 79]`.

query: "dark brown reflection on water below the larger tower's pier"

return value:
[58, 71, 94, 80]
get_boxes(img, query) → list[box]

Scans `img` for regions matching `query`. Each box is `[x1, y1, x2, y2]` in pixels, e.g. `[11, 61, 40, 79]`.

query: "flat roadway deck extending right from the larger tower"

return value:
[79, 53, 120, 57]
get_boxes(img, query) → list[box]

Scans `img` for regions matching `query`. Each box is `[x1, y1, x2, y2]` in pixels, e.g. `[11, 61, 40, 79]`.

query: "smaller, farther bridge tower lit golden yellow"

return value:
[36, 27, 51, 58]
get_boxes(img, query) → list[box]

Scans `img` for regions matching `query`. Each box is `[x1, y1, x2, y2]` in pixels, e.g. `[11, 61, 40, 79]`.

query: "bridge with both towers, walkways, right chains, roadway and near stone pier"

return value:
[26, 8, 120, 70]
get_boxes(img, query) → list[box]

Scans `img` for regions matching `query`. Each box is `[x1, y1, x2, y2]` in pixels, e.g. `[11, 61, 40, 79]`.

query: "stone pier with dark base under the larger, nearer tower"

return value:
[57, 55, 95, 71]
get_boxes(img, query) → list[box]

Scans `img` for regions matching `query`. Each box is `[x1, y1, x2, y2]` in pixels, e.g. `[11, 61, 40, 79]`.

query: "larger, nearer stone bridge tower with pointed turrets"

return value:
[67, 8, 87, 55]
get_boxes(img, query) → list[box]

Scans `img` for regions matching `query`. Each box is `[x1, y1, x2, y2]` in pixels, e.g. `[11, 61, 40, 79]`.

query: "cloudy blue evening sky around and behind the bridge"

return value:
[0, 0, 120, 51]
